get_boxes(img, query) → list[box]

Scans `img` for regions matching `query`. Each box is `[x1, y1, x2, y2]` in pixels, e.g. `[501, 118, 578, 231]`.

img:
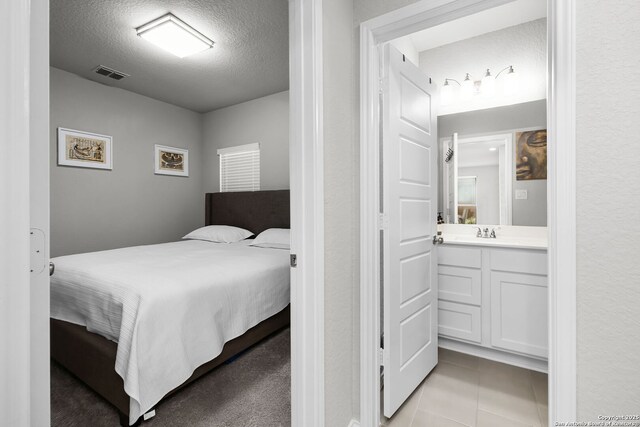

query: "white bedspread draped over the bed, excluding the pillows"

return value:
[51, 240, 290, 423]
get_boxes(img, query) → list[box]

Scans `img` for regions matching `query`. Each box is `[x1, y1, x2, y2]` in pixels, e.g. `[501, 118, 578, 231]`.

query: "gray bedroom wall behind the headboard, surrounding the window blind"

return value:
[202, 91, 289, 193]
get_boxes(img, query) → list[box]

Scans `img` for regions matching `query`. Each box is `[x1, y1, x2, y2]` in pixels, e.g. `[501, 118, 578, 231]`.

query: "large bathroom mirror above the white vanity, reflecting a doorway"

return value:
[438, 100, 547, 226]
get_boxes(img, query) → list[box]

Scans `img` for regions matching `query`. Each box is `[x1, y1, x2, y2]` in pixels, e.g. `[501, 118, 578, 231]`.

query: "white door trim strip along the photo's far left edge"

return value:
[0, 1, 31, 426]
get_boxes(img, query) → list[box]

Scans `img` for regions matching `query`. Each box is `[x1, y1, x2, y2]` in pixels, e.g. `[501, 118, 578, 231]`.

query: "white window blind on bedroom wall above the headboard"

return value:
[218, 144, 260, 193]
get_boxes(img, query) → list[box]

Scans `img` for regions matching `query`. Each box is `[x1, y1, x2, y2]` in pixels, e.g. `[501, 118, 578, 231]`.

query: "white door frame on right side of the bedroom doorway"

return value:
[289, 0, 324, 427]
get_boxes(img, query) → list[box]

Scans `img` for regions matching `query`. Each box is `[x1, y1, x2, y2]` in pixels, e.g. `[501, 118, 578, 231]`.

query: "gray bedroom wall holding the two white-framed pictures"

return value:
[51, 68, 204, 256]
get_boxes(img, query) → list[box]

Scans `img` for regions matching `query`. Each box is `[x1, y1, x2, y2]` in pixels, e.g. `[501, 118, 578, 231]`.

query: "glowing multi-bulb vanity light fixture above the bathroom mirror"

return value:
[440, 65, 518, 105]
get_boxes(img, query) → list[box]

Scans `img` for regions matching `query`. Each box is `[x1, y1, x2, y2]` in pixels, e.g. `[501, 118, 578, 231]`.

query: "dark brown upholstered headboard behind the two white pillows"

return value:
[205, 190, 291, 235]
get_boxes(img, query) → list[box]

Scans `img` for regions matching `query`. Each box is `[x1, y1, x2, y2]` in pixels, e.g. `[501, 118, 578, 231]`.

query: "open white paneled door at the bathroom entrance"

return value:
[381, 44, 438, 417]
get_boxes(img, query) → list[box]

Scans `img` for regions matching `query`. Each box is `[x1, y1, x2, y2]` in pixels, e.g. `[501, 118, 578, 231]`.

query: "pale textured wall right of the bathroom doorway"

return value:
[576, 0, 640, 421]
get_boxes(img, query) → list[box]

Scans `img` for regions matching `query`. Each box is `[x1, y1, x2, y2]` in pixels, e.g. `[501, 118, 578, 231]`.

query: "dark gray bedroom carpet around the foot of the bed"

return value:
[51, 328, 291, 427]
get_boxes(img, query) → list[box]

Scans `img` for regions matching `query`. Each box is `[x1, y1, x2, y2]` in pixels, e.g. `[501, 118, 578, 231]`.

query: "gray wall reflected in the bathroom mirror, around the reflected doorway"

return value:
[438, 100, 547, 226]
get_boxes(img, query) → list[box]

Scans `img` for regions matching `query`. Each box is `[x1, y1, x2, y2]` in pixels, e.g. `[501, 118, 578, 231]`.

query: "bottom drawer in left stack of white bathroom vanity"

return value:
[438, 301, 482, 343]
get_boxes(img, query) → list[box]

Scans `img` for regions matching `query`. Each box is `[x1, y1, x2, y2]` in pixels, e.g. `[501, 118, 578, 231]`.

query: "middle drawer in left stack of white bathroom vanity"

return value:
[438, 265, 482, 305]
